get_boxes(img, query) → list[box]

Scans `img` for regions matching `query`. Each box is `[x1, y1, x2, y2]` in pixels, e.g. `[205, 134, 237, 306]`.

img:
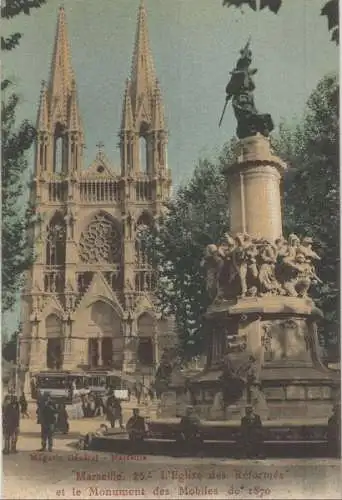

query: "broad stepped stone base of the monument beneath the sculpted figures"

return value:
[159, 297, 340, 424]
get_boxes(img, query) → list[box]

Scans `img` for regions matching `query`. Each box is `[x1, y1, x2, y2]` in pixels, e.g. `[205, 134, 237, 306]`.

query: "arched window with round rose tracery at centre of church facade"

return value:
[80, 213, 121, 264]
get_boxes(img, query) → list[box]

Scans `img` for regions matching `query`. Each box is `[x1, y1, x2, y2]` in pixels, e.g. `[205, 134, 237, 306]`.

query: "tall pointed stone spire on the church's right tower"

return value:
[131, 0, 156, 107]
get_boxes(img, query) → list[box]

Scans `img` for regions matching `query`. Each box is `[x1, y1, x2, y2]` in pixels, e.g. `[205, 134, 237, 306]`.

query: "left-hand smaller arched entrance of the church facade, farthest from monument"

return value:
[45, 314, 64, 370]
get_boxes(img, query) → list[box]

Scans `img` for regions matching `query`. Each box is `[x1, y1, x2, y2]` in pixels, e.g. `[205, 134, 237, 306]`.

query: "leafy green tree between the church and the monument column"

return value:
[142, 145, 235, 359]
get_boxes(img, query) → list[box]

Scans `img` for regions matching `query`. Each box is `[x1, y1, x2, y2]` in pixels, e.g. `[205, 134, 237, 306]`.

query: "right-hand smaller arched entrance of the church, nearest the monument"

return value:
[137, 313, 156, 368]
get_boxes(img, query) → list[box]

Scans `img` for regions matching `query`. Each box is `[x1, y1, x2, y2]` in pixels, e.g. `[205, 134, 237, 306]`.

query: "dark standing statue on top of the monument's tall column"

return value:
[220, 40, 274, 139]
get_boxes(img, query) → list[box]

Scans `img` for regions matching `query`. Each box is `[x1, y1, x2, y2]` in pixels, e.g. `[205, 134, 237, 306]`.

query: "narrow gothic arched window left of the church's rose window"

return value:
[46, 212, 66, 266]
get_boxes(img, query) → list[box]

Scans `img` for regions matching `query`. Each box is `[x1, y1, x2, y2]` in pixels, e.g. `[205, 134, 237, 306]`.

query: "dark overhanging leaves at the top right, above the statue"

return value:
[223, 0, 339, 44]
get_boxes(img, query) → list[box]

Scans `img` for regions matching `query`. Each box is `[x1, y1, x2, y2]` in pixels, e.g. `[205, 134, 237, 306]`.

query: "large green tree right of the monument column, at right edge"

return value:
[274, 75, 340, 346]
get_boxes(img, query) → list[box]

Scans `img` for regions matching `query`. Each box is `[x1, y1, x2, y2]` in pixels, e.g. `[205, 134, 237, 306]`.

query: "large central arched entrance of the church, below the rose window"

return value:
[87, 301, 123, 370]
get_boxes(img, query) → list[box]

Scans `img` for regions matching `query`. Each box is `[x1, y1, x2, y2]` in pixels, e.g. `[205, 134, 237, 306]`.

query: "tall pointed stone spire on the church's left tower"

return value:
[49, 7, 74, 121]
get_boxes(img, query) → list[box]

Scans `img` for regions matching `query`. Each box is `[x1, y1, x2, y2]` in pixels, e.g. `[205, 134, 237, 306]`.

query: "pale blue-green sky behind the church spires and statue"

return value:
[2, 0, 338, 336]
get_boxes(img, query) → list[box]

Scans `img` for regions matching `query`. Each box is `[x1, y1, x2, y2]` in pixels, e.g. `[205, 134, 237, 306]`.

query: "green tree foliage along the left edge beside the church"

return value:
[1, 0, 46, 312]
